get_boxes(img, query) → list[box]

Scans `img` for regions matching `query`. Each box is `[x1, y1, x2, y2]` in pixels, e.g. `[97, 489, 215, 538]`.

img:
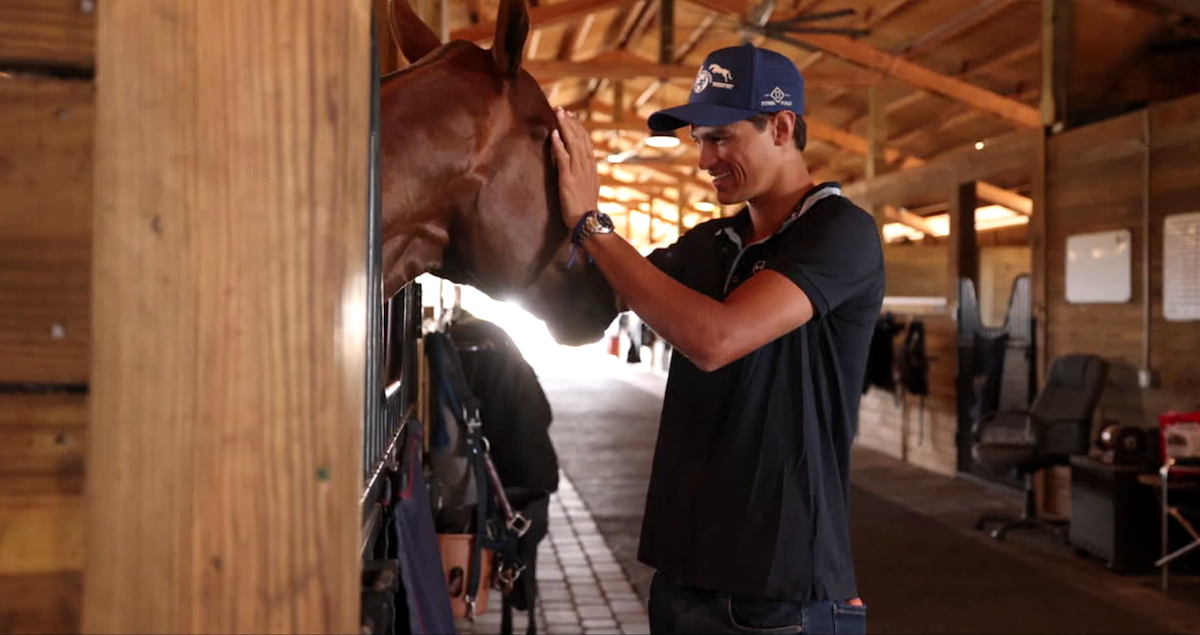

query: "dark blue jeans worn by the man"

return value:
[649, 571, 866, 635]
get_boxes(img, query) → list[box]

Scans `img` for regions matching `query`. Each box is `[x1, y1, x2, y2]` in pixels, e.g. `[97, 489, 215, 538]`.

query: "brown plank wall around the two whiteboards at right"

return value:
[1045, 90, 1200, 514]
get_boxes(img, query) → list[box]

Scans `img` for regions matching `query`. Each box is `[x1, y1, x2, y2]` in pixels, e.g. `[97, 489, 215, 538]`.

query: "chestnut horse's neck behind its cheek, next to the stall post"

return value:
[380, 73, 474, 295]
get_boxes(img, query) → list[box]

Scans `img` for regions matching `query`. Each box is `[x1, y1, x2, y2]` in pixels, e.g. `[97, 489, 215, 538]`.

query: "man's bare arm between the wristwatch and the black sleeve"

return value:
[584, 234, 812, 371]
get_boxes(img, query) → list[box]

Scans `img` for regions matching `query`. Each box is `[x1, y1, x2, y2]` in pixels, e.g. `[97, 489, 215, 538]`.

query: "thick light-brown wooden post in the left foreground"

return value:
[83, 0, 373, 633]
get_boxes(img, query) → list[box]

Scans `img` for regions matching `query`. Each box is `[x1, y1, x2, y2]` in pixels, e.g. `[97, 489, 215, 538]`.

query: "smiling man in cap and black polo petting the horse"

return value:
[551, 46, 883, 633]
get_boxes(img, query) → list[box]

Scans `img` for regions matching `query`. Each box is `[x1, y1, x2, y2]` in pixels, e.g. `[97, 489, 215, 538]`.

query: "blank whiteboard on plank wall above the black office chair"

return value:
[1067, 229, 1133, 304]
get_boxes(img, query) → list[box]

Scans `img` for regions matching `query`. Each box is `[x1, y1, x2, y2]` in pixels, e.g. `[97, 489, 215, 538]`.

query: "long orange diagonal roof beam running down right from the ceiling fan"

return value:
[691, 0, 1042, 128]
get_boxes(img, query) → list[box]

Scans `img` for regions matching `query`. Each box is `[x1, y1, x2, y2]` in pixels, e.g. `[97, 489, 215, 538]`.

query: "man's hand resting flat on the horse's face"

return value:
[550, 108, 600, 227]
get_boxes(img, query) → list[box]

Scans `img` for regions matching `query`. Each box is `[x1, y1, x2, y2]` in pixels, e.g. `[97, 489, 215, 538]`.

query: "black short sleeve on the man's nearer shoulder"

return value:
[766, 204, 883, 317]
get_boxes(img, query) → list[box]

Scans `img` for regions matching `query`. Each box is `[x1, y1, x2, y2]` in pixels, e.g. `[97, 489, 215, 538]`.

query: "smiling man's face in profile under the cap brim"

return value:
[691, 114, 791, 205]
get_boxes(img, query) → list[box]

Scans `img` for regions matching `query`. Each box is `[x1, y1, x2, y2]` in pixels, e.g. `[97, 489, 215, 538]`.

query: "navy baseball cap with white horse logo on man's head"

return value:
[648, 44, 804, 132]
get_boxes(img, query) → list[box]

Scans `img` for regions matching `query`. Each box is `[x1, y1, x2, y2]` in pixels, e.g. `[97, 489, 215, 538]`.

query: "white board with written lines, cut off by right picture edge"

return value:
[1163, 211, 1200, 322]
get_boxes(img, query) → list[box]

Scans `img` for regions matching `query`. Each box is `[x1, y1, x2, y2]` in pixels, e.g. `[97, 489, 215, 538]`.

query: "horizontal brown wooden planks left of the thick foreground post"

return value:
[0, 0, 96, 633]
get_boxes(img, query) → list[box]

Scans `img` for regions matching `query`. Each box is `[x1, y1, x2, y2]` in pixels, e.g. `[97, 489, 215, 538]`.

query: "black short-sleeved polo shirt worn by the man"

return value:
[638, 184, 883, 601]
